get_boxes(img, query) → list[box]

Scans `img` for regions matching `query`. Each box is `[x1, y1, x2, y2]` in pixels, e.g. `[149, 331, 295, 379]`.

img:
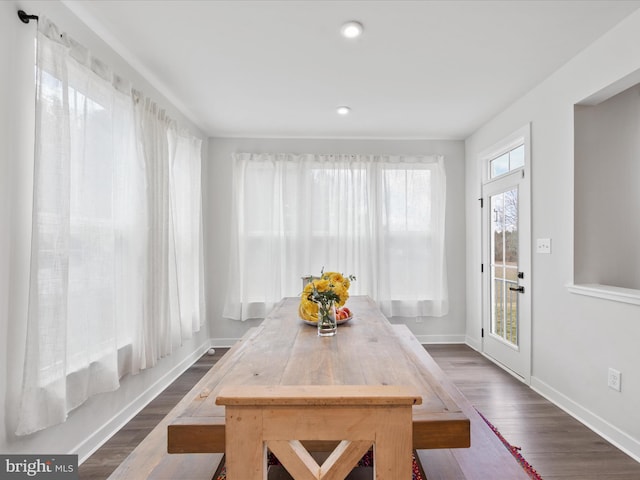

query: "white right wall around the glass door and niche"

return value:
[466, 12, 640, 459]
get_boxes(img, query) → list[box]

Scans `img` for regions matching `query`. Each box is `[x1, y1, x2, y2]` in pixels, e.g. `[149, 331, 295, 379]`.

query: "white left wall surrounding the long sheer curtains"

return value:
[0, 1, 209, 459]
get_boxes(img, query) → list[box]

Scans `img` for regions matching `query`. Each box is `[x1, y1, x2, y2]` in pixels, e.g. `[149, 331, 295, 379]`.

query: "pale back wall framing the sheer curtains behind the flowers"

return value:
[203, 138, 466, 345]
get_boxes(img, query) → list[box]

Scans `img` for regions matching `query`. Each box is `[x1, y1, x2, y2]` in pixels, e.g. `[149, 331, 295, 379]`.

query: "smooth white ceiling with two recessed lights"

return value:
[63, 0, 640, 139]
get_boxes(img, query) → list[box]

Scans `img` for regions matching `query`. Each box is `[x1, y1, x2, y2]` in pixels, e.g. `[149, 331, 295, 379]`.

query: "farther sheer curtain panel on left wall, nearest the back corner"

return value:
[132, 94, 204, 371]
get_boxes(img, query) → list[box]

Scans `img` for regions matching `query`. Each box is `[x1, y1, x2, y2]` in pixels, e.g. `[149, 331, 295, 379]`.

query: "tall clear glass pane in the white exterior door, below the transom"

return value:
[490, 189, 518, 345]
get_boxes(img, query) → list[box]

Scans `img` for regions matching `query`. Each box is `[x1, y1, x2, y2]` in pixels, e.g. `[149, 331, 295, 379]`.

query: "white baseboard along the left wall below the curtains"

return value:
[71, 340, 212, 464]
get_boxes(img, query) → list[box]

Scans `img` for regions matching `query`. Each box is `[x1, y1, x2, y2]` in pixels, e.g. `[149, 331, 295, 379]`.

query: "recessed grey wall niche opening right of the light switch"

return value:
[573, 78, 640, 294]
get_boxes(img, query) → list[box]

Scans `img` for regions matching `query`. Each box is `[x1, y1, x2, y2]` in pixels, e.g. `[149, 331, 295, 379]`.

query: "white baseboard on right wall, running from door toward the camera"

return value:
[531, 376, 640, 462]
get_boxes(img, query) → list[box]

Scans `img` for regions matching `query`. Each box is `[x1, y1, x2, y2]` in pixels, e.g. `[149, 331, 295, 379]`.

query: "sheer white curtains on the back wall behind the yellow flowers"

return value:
[224, 153, 448, 320]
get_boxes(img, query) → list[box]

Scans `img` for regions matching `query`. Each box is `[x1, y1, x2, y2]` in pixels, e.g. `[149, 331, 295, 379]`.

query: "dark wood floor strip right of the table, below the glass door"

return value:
[426, 345, 640, 480]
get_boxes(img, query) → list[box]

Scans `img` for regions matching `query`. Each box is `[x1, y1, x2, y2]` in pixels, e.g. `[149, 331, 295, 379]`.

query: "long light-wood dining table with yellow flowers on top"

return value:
[167, 296, 471, 453]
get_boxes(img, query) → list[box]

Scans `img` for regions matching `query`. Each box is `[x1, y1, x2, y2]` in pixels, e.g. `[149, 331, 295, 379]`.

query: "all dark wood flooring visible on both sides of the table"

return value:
[79, 345, 640, 480]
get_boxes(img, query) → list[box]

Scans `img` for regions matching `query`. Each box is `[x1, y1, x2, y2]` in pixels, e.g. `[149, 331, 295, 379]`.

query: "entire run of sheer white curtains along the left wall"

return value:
[16, 17, 202, 435]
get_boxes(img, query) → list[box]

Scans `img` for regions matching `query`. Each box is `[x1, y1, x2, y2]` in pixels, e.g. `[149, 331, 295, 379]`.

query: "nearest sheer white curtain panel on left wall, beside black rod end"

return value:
[17, 19, 145, 434]
